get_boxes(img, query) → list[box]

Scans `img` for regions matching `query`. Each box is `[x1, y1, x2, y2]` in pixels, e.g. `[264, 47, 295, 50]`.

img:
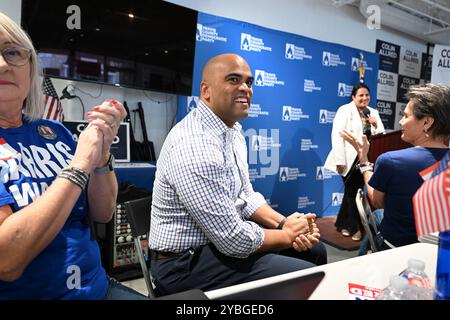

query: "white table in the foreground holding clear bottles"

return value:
[205, 243, 438, 300]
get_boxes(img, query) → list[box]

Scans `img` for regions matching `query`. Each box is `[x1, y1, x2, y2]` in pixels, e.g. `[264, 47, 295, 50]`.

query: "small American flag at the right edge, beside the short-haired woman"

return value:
[413, 151, 450, 237]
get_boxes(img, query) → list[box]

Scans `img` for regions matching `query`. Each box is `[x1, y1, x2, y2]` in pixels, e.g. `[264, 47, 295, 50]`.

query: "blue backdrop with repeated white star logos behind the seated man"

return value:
[177, 13, 378, 216]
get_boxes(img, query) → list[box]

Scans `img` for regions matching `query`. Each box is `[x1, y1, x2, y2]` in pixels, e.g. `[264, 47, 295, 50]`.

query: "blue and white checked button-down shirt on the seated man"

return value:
[149, 101, 266, 258]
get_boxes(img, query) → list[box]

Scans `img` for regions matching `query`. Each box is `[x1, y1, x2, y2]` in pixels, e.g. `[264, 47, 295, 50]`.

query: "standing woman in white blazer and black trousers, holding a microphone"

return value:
[324, 83, 384, 241]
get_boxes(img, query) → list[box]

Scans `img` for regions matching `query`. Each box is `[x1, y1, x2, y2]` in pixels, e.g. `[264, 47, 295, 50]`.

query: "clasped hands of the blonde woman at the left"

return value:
[70, 99, 126, 173]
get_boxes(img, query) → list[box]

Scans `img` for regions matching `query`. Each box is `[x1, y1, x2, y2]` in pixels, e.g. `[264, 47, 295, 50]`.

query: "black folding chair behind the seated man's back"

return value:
[124, 196, 156, 298]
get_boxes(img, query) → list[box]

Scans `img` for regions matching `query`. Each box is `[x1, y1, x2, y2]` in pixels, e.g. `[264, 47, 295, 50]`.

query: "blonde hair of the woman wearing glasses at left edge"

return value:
[0, 12, 44, 120]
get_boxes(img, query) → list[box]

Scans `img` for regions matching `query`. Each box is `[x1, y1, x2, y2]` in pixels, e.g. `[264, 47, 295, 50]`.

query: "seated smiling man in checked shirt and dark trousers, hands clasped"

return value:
[149, 54, 327, 294]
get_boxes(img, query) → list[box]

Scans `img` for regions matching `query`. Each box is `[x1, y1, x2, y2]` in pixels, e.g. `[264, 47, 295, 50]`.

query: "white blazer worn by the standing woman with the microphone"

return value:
[324, 101, 384, 177]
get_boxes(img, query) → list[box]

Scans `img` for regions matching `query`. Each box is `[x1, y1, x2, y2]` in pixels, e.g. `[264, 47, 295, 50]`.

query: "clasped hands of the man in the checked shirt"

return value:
[282, 212, 320, 251]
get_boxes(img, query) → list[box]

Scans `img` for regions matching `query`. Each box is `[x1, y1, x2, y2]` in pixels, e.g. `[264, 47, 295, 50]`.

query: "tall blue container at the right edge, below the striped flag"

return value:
[434, 231, 450, 300]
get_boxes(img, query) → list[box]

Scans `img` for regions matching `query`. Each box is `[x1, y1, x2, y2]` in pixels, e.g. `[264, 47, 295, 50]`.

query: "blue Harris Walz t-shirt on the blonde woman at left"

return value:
[0, 117, 108, 300]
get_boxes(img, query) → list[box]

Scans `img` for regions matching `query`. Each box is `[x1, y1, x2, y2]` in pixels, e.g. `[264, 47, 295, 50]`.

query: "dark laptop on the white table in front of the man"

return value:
[220, 271, 325, 300]
